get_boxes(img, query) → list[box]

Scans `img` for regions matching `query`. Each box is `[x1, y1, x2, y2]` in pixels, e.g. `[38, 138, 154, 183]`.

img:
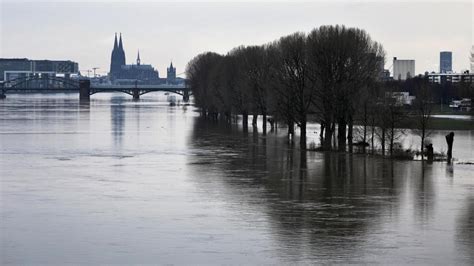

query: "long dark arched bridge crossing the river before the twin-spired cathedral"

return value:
[0, 76, 191, 102]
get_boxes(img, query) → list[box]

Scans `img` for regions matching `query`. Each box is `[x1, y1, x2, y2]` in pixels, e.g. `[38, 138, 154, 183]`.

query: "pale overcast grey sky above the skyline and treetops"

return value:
[0, 0, 474, 77]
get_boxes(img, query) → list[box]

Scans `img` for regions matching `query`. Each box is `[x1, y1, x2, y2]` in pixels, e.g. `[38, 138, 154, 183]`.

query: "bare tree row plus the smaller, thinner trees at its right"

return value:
[186, 26, 472, 155]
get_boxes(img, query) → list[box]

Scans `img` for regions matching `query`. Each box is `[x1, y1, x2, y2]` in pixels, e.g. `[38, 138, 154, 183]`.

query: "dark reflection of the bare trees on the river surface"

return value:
[189, 120, 472, 263]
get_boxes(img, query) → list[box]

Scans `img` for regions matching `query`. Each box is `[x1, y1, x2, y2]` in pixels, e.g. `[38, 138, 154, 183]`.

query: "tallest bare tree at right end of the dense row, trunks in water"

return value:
[308, 25, 384, 150]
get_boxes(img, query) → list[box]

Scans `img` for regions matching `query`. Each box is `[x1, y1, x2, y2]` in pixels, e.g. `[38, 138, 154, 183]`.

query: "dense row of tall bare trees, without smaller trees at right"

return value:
[186, 26, 384, 150]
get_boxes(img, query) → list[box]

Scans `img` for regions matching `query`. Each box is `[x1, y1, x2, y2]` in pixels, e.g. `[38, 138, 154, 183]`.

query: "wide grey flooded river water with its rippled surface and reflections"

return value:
[0, 94, 474, 265]
